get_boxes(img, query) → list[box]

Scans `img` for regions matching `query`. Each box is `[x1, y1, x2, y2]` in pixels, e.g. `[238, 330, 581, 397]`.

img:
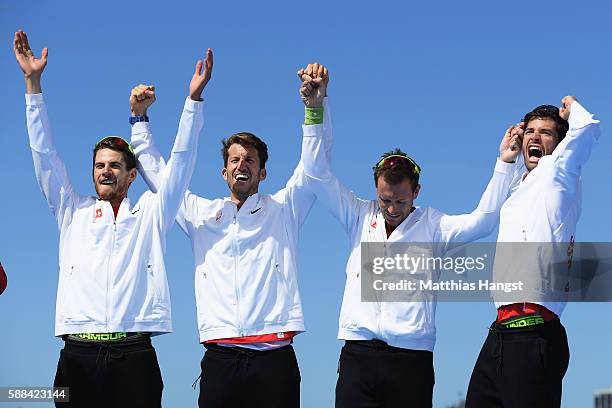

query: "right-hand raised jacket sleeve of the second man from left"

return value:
[282, 97, 333, 230]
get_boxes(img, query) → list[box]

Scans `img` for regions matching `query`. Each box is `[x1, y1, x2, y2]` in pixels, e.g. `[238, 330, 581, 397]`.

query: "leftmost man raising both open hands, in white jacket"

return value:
[13, 31, 212, 408]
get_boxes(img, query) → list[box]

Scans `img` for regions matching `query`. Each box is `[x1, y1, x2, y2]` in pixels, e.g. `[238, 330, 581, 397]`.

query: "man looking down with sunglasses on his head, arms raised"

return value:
[301, 69, 520, 408]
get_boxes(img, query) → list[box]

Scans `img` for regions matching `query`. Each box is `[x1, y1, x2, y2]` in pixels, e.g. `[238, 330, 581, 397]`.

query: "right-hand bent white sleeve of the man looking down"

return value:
[434, 159, 516, 253]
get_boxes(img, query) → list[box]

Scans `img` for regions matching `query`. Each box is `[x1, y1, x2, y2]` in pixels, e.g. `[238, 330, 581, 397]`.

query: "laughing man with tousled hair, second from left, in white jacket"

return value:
[132, 63, 329, 408]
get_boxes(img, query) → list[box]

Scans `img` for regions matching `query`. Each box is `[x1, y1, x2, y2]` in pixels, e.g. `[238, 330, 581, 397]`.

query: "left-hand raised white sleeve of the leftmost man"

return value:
[26, 94, 78, 230]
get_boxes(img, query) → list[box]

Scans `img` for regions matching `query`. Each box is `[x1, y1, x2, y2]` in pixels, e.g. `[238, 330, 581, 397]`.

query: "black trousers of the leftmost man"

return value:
[53, 336, 164, 408]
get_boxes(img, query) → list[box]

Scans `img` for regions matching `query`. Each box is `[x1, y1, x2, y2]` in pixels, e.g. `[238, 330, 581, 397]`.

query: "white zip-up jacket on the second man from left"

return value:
[132, 102, 331, 342]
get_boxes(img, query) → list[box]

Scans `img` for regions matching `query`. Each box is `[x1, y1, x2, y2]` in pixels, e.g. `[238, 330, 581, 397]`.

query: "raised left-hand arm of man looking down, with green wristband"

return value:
[298, 66, 367, 237]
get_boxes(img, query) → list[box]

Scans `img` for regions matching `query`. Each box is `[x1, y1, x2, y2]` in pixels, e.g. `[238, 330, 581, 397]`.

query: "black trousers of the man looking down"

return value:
[336, 340, 434, 408]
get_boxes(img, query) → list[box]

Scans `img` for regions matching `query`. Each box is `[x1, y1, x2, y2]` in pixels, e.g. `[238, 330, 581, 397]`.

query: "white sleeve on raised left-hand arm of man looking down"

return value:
[301, 110, 369, 238]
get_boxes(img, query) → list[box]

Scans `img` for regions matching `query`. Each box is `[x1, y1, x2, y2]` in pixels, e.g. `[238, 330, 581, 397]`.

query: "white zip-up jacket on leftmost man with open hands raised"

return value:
[26, 94, 203, 336]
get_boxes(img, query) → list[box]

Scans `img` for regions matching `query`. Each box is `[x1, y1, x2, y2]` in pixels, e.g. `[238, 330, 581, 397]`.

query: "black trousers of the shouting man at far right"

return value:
[465, 319, 569, 408]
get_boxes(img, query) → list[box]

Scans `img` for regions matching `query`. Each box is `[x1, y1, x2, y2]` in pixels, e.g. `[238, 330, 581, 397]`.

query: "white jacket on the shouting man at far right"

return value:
[493, 101, 600, 316]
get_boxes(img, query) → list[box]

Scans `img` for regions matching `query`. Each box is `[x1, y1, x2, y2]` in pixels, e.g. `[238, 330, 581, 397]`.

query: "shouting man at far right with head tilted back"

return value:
[466, 96, 599, 408]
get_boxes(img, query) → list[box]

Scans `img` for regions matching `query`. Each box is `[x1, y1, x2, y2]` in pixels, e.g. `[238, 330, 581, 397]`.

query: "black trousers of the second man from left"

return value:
[198, 344, 301, 408]
